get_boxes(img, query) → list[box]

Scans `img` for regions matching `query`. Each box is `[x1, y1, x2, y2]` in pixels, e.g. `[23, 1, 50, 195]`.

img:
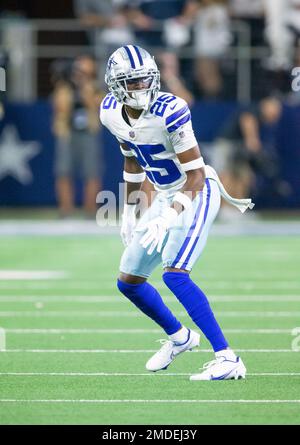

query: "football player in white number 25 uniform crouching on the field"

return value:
[100, 45, 254, 380]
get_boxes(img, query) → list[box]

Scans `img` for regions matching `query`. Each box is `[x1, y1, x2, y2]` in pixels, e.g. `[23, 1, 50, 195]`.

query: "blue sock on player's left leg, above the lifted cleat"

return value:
[117, 280, 181, 335]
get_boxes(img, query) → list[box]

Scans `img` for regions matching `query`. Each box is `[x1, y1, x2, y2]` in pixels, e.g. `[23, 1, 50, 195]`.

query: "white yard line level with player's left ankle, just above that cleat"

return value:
[5, 328, 293, 335]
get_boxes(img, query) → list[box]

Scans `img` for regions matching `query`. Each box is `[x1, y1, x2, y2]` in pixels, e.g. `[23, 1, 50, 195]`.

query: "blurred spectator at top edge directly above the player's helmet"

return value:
[74, 0, 134, 58]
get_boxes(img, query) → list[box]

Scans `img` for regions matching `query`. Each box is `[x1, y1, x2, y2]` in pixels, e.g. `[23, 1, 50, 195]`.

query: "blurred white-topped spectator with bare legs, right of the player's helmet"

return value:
[194, 0, 232, 98]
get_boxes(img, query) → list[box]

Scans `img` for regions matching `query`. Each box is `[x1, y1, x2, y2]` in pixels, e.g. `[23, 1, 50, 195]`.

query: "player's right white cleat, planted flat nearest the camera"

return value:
[190, 356, 247, 380]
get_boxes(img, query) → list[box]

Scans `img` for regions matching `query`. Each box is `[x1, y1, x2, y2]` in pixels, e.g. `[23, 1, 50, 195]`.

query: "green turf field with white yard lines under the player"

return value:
[0, 232, 300, 425]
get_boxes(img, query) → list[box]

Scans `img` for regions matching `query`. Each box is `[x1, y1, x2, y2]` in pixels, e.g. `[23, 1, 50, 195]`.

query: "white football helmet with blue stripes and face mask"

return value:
[105, 45, 160, 110]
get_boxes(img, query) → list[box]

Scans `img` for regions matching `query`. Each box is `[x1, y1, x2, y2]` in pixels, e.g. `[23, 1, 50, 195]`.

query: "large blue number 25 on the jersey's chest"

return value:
[125, 141, 181, 185]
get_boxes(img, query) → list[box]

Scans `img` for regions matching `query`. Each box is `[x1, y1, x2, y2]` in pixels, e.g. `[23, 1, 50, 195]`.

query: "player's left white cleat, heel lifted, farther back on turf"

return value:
[146, 329, 200, 372]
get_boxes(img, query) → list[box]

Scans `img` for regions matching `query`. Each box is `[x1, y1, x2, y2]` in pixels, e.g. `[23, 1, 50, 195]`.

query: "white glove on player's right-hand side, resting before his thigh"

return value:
[140, 207, 178, 255]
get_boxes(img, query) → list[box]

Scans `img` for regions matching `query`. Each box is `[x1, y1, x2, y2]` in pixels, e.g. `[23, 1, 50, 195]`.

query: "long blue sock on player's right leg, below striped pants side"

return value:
[163, 272, 228, 352]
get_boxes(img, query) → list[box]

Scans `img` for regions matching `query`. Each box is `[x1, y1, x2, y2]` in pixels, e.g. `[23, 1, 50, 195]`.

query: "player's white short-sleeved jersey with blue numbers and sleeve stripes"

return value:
[100, 92, 197, 192]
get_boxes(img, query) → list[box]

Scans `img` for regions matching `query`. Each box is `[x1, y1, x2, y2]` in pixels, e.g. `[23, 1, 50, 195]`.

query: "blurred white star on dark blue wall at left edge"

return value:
[0, 126, 41, 185]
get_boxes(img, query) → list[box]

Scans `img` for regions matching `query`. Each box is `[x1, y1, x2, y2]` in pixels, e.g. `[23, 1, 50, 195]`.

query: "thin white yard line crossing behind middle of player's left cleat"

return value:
[2, 349, 300, 354]
